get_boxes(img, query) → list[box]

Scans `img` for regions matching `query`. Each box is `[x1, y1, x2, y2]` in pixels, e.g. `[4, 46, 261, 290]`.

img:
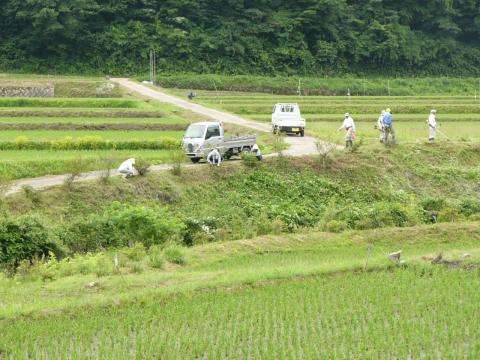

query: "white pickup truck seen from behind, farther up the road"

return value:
[272, 103, 305, 137]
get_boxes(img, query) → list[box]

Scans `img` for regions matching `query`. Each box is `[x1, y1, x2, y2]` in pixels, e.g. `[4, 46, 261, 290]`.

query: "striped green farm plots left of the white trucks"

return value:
[0, 94, 194, 180]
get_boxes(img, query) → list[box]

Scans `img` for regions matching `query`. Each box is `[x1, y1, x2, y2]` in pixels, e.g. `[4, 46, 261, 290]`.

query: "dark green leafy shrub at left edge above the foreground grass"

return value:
[0, 216, 62, 271]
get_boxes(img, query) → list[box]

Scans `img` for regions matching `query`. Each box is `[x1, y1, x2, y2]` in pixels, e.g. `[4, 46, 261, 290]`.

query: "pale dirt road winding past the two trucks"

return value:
[4, 78, 332, 195]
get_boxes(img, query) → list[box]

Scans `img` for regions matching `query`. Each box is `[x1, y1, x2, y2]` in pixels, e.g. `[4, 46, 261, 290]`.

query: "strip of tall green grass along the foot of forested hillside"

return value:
[157, 74, 480, 97]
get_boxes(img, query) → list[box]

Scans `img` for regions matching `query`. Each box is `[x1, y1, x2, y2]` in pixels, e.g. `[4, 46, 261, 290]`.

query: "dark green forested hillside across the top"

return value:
[0, 0, 480, 75]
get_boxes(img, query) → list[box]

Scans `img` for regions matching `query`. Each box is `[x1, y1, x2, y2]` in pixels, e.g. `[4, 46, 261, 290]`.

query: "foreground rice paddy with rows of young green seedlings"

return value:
[0, 267, 480, 359]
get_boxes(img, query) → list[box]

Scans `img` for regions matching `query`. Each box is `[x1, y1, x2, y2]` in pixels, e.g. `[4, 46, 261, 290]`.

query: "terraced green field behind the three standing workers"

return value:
[170, 90, 480, 144]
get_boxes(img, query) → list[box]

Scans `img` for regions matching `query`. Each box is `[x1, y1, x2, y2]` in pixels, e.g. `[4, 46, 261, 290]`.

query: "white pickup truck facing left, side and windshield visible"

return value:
[182, 121, 257, 163]
